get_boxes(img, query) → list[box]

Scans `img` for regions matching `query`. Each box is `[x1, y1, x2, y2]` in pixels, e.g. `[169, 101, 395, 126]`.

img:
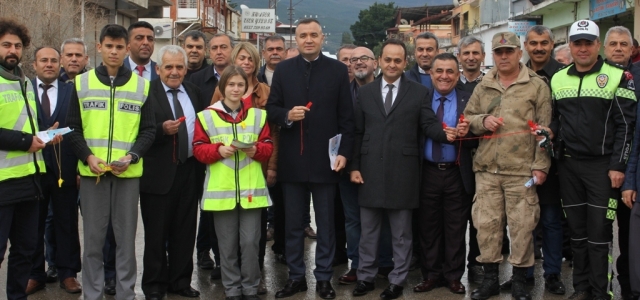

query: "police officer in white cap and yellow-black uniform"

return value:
[551, 20, 636, 299]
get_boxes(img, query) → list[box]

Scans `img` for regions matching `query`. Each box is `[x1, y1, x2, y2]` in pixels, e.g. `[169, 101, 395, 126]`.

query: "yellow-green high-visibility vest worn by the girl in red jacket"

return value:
[198, 108, 271, 211]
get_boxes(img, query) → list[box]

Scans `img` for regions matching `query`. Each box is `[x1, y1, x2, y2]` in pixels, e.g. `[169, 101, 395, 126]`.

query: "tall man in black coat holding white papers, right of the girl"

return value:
[267, 19, 353, 299]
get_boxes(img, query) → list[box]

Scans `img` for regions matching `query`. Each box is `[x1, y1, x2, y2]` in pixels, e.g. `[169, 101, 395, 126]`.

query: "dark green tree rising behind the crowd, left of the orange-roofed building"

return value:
[351, 2, 396, 49]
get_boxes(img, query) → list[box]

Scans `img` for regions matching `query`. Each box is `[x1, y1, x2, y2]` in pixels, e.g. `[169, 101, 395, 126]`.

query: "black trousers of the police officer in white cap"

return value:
[558, 156, 620, 297]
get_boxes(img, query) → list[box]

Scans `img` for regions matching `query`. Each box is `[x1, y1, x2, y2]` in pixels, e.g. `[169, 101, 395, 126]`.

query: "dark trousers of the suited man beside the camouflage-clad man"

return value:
[419, 162, 473, 281]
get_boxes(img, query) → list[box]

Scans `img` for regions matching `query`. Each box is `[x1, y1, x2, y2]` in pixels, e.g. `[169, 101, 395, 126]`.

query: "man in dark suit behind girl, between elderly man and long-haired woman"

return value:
[188, 33, 233, 280]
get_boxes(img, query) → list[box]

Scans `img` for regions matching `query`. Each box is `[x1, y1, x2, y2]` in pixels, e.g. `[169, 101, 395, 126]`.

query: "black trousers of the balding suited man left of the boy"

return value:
[29, 171, 82, 282]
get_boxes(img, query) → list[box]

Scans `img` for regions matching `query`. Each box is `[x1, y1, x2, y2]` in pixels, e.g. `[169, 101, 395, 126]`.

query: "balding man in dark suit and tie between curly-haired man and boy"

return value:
[27, 47, 82, 294]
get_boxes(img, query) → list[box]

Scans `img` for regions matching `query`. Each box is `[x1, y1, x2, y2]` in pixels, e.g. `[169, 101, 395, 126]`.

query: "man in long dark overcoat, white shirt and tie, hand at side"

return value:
[349, 39, 442, 299]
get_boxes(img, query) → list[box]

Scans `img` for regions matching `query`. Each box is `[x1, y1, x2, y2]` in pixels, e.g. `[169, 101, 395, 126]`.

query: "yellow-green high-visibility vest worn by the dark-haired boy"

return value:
[75, 70, 149, 178]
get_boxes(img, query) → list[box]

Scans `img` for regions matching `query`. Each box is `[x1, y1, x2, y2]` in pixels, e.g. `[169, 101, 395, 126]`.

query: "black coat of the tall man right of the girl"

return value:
[266, 54, 353, 183]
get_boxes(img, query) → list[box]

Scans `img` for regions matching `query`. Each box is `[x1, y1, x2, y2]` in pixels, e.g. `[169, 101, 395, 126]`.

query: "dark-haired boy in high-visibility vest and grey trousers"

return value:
[67, 24, 155, 300]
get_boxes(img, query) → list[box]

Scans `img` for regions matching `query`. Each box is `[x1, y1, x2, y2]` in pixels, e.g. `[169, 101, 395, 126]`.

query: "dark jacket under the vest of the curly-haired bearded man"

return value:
[0, 66, 45, 205]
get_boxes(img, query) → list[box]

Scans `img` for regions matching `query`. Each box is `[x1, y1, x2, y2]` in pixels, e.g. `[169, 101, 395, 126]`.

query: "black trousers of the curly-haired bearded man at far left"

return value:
[0, 198, 38, 300]
